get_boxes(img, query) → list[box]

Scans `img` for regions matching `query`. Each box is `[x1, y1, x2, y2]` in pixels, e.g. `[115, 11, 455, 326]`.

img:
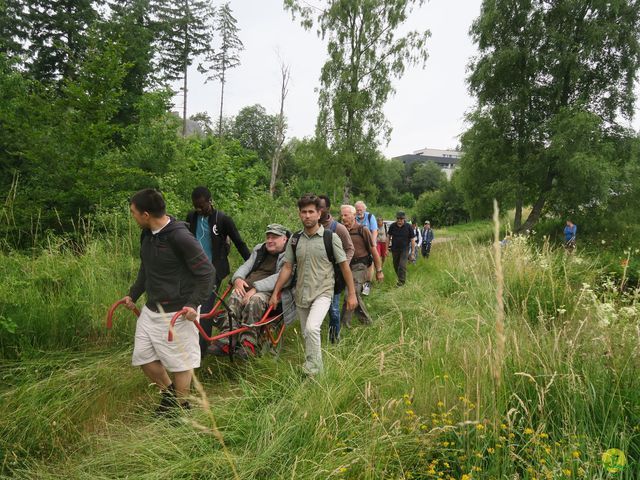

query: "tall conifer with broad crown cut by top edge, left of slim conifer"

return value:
[157, 0, 214, 135]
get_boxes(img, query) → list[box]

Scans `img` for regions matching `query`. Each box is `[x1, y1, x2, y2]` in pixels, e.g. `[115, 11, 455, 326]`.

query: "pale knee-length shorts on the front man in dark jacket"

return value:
[131, 306, 200, 372]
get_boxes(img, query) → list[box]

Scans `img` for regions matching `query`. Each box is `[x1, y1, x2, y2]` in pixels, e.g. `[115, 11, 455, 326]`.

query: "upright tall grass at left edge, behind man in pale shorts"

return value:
[0, 214, 139, 358]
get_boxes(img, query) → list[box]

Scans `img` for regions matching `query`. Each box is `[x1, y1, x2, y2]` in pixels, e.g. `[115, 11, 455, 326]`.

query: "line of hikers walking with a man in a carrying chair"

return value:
[122, 187, 433, 414]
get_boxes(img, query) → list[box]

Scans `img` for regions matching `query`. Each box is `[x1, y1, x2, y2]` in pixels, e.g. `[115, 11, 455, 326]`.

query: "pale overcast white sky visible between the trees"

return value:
[176, 0, 640, 157]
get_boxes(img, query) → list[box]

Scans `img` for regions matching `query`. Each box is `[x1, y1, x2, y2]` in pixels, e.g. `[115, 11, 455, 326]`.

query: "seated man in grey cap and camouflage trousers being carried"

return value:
[207, 223, 295, 359]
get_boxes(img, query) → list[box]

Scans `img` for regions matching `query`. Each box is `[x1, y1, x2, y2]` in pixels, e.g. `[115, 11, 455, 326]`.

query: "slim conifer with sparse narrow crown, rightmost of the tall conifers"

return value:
[200, 2, 244, 136]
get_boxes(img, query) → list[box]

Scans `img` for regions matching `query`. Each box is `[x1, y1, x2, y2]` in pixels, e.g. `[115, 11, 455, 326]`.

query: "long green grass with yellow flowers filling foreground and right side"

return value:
[0, 213, 640, 479]
